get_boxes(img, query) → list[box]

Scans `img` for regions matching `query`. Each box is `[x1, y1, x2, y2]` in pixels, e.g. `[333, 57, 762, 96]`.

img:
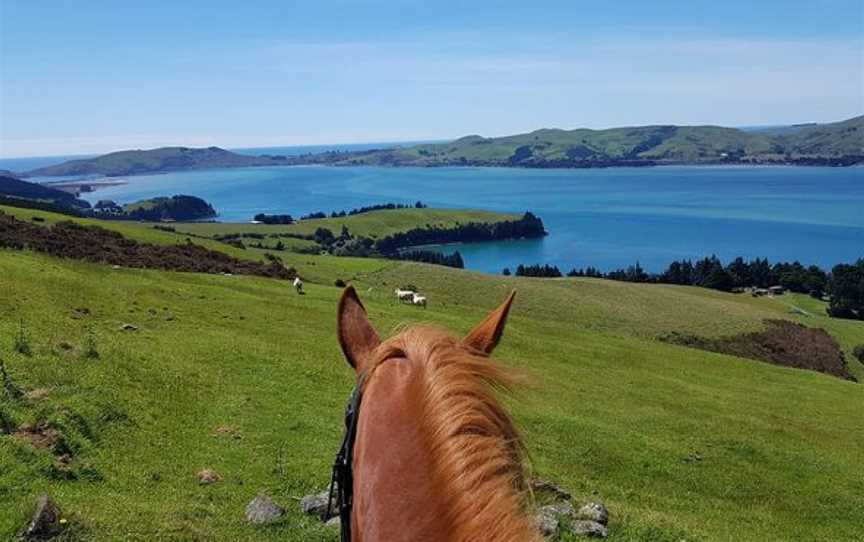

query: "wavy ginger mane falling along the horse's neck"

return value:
[373, 326, 542, 542]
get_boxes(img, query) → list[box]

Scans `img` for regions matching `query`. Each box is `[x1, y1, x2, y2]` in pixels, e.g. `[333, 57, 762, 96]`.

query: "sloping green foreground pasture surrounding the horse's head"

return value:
[0, 209, 864, 541]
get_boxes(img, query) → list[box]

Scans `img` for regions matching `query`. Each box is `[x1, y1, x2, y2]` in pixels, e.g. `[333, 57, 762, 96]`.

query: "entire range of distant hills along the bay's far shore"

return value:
[27, 116, 864, 176]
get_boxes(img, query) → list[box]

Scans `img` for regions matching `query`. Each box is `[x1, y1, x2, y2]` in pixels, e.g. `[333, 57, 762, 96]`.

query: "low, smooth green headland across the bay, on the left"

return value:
[26, 147, 286, 177]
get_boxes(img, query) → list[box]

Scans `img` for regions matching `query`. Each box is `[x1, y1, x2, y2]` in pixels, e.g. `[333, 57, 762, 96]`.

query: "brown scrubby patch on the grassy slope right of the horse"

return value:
[661, 320, 857, 382]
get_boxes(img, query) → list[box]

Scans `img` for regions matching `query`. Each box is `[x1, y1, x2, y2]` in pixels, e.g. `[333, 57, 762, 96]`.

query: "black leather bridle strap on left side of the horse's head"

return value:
[327, 371, 366, 542]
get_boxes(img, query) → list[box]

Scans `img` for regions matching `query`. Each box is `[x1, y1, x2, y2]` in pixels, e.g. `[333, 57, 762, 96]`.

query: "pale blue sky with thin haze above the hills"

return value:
[0, 0, 864, 157]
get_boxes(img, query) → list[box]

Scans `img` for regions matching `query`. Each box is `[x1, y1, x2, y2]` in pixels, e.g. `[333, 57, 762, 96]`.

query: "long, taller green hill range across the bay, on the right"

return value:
[295, 116, 864, 167]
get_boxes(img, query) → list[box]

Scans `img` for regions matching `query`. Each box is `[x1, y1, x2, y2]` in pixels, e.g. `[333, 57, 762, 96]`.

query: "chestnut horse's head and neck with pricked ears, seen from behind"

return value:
[338, 286, 542, 542]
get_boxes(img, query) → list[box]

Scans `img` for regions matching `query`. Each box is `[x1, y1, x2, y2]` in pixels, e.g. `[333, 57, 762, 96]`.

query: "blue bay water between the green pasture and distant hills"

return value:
[57, 166, 864, 273]
